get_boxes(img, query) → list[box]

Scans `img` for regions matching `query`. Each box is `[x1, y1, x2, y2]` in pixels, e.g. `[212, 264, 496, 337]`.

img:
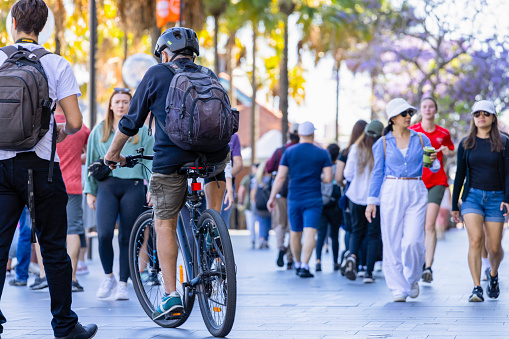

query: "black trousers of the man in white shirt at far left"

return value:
[0, 152, 78, 337]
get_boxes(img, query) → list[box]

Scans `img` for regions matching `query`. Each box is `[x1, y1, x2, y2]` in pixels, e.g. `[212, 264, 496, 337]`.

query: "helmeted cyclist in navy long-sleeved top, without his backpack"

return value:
[105, 27, 230, 320]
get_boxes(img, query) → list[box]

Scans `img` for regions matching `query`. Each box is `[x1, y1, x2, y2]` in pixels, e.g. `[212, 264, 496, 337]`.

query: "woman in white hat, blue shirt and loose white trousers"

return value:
[366, 98, 440, 302]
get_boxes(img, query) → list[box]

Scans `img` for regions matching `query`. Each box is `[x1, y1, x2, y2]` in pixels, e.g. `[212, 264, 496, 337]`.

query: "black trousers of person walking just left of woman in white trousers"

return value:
[350, 201, 382, 273]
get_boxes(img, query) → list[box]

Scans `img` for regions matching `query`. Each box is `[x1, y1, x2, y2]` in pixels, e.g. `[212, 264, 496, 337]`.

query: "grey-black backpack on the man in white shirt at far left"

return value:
[0, 46, 56, 151]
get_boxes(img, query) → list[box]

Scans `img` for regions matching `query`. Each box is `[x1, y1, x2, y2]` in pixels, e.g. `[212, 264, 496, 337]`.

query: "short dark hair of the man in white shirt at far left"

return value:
[11, 0, 48, 35]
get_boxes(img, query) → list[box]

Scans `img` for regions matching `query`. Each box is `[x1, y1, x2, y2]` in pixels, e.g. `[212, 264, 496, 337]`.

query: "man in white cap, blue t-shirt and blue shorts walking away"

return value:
[267, 121, 332, 278]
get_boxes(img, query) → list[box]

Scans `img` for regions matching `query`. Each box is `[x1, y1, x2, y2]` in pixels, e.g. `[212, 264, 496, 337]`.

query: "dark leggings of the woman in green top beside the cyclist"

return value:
[97, 177, 146, 282]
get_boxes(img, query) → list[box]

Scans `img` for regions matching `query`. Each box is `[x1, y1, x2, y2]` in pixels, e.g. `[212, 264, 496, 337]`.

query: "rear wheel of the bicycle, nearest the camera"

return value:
[194, 209, 237, 337]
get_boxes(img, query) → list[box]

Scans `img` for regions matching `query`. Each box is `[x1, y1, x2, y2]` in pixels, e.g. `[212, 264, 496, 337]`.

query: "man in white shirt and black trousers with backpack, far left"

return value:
[0, 0, 97, 338]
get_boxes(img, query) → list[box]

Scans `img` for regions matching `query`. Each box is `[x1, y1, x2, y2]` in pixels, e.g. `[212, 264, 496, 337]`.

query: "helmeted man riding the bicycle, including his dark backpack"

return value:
[104, 27, 239, 320]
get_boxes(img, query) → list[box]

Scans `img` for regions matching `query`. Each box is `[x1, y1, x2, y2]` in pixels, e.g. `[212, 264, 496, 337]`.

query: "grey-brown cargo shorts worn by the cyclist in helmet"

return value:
[149, 153, 230, 220]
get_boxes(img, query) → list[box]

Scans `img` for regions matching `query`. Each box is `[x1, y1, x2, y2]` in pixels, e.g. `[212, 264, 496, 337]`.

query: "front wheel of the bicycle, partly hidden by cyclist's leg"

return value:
[129, 210, 195, 328]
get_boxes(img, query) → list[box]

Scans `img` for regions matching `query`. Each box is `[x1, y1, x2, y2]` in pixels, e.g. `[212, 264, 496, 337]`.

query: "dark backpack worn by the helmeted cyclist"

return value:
[153, 62, 239, 152]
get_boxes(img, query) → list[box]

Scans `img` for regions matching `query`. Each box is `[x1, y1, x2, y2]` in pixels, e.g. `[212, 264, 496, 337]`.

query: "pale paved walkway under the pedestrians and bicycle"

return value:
[0, 230, 509, 339]
